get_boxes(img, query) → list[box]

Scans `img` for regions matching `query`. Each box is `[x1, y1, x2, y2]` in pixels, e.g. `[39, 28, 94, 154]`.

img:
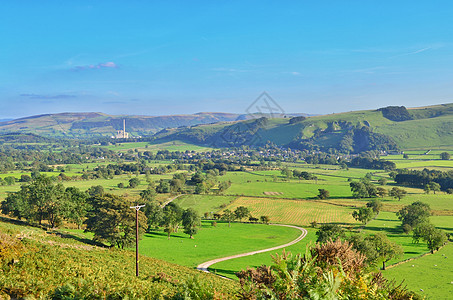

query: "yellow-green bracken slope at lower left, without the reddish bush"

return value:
[0, 219, 237, 299]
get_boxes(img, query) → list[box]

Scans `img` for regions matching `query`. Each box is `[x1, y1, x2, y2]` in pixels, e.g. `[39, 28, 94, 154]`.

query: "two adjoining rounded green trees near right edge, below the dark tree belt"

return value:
[396, 201, 447, 253]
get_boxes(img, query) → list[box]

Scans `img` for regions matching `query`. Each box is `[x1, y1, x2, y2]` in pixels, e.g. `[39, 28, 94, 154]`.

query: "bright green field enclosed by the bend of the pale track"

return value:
[140, 221, 300, 267]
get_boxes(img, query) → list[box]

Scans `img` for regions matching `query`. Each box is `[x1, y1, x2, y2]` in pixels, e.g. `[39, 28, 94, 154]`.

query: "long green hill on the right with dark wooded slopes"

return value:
[154, 103, 453, 152]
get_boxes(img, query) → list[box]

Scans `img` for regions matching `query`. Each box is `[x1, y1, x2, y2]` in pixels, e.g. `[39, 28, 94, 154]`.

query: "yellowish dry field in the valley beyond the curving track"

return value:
[222, 197, 357, 226]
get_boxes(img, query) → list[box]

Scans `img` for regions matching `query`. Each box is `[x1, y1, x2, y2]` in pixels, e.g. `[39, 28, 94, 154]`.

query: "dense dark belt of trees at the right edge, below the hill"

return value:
[394, 169, 453, 192]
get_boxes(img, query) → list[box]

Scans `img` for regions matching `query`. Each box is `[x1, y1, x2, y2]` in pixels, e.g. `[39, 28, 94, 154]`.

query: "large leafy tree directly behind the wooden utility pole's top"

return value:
[84, 193, 147, 249]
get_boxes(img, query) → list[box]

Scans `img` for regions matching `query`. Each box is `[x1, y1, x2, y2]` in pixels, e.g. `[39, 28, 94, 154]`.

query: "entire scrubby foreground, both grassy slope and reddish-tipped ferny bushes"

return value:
[0, 222, 418, 299]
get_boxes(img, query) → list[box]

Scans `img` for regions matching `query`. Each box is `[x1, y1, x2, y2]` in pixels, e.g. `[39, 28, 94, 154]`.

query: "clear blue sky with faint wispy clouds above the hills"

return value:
[0, 0, 453, 118]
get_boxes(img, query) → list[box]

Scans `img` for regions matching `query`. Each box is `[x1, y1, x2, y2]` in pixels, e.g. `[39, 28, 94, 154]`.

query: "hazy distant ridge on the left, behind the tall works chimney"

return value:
[0, 112, 306, 138]
